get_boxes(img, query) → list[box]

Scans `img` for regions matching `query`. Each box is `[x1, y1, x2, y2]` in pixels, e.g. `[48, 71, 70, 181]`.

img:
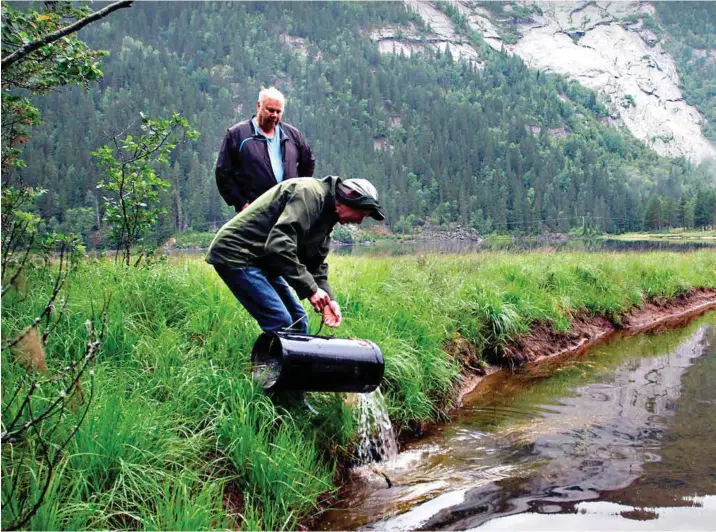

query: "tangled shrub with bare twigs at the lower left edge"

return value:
[2, 230, 97, 529]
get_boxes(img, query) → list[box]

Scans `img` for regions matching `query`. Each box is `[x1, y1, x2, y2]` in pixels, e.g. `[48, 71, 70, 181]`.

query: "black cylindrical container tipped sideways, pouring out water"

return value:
[251, 332, 385, 393]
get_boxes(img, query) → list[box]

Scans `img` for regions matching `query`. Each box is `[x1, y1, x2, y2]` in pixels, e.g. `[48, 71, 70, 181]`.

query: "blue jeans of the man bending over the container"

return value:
[214, 264, 308, 334]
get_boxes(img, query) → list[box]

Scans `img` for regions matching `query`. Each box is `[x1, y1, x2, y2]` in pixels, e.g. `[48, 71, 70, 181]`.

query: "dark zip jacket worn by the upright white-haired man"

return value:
[216, 120, 316, 212]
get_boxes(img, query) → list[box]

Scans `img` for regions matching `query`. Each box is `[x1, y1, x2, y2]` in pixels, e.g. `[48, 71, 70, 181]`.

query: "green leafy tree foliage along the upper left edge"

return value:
[2, 2, 111, 280]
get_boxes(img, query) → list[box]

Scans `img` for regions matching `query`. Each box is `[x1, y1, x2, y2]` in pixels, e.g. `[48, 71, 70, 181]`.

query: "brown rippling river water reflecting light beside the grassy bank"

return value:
[319, 312, 716, 530]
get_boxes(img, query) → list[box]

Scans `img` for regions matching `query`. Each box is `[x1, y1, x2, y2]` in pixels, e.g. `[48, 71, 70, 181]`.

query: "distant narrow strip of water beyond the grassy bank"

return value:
[332, 238, 716, 256]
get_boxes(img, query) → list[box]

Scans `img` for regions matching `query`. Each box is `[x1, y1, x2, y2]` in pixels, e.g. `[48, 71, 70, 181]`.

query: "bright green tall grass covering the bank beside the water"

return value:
[2, 251, 716, 530]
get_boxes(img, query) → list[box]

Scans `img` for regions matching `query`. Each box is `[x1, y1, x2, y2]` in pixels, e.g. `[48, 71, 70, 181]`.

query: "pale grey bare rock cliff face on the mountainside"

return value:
[372, 0, 716, 163]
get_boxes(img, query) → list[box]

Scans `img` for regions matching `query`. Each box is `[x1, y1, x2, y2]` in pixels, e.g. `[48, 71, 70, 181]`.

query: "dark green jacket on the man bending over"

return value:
[206, 176, 338, 299]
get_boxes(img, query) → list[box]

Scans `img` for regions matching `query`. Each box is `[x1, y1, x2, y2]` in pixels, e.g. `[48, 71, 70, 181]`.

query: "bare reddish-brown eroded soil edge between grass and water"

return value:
[454, 288, 716, 408]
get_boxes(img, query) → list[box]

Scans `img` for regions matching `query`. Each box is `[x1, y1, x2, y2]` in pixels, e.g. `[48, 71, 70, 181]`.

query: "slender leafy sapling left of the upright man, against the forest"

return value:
[92, 113, 199, 266]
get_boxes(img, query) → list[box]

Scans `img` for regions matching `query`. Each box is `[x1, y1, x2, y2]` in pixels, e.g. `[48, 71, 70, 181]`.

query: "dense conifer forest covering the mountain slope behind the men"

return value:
[7, 2, 716, 245]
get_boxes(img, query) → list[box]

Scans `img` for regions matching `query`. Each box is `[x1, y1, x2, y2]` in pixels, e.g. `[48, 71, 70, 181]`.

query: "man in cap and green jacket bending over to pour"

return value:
[206, 176, 385, 334]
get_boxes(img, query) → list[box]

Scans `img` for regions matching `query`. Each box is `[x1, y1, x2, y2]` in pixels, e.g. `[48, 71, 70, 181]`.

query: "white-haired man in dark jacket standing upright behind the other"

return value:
[216, 87, 316, 212]
